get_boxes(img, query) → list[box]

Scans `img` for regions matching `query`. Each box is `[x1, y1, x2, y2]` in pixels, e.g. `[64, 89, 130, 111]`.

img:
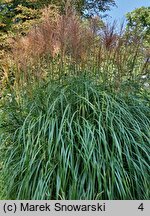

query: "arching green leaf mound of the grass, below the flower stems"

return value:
[1, 76, 150, 200]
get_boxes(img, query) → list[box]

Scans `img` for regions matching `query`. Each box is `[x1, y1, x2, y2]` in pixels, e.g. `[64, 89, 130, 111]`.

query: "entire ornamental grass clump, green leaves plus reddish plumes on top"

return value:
[0, 4, 150, 200]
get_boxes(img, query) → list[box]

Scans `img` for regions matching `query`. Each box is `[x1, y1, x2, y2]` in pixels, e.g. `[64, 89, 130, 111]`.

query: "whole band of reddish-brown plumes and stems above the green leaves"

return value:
[3, 4, 148, 92]
